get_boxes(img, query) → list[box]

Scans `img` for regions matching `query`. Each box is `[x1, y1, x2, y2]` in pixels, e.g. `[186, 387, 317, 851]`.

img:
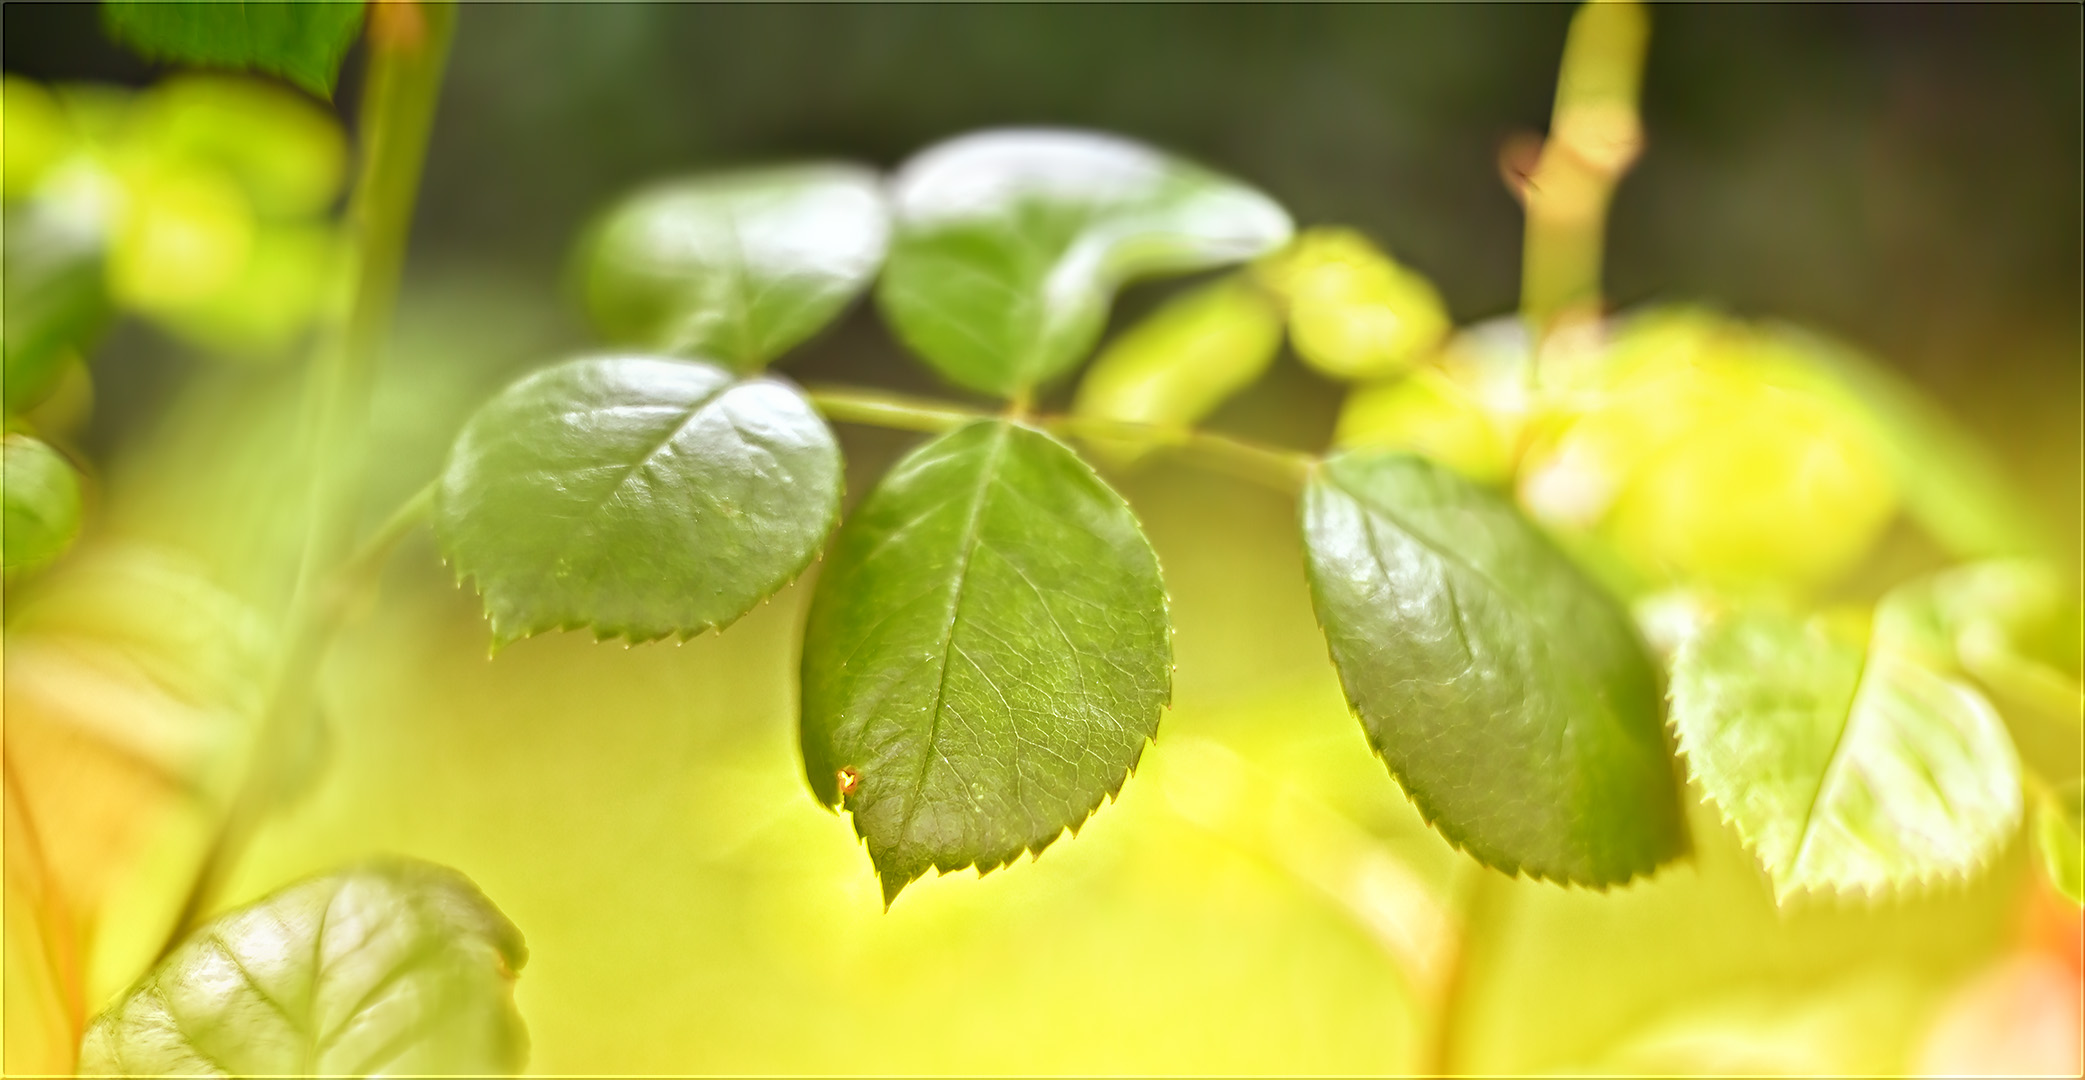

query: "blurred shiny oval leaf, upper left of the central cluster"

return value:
[582, 165, 890, 371]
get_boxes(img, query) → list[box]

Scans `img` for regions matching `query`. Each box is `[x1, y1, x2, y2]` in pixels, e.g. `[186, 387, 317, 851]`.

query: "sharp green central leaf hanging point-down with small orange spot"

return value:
[803, 421, 1172, 903]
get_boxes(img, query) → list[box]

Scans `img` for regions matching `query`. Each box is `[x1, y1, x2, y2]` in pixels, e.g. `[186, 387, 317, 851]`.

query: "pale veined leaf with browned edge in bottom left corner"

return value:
[79, 859, 528, 1076]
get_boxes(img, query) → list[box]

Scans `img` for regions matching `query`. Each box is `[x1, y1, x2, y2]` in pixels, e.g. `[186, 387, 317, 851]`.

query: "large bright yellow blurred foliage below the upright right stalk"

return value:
[1520, 311, 1897, 588]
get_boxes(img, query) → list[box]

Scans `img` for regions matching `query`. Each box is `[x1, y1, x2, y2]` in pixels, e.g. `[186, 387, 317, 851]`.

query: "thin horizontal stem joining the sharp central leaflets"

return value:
[807, 388, 1318, 492]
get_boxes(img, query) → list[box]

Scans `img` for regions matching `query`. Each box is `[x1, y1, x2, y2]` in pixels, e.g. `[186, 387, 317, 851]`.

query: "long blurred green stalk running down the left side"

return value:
[161, 0, 457, 955]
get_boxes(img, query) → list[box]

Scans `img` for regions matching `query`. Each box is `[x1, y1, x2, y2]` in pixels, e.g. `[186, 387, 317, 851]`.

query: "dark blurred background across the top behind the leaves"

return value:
[16, 4, 2085, 538]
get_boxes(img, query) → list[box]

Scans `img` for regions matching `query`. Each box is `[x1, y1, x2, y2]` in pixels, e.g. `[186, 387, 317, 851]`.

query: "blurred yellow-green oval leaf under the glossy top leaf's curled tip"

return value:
[1074, 277, 1282, 455]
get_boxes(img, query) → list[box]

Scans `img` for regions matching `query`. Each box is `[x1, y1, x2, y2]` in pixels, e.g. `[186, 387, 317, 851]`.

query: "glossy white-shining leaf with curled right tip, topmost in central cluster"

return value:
[878, 131, 1291, 396]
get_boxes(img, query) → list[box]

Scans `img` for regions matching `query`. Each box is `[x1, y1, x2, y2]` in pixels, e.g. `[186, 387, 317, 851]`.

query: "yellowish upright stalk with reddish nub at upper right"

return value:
[1516, 0, 1651, 354]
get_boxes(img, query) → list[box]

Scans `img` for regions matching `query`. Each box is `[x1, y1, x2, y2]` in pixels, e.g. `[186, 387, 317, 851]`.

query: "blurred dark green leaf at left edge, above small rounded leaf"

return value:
[0, 206, 111, 415]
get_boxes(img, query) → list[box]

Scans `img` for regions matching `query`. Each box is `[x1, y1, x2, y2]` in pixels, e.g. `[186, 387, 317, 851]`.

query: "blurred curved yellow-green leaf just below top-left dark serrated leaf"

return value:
[125, 75, 348, 217]
